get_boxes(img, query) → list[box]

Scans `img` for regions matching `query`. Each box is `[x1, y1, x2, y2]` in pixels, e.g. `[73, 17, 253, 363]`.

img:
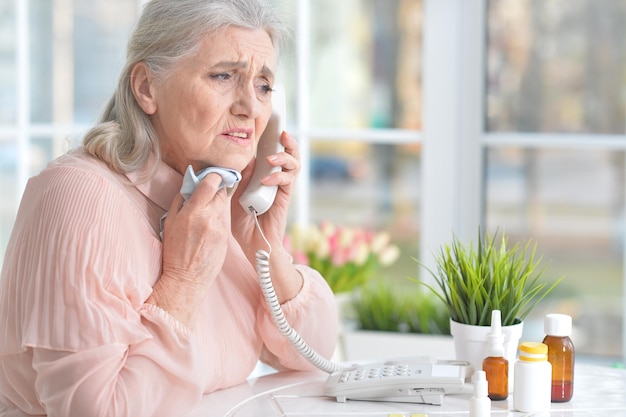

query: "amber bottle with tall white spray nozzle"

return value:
[483, 310, 509, 401]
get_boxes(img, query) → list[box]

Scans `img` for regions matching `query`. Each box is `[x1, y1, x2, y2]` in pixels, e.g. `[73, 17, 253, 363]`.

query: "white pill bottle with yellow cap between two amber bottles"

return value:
[513, 342, 552, 413]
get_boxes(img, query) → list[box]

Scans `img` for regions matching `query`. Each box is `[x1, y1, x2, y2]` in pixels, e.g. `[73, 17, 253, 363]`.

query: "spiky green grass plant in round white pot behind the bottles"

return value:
[416, 230, 563, 369]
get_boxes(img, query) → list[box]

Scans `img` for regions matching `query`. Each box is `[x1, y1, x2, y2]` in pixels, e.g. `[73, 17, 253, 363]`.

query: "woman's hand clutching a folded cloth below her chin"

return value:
[147, 174, 230, 329]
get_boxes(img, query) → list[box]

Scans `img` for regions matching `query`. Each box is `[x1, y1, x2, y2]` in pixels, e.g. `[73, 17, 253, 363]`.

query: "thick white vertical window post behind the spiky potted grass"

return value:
[420, 0, 486, 272]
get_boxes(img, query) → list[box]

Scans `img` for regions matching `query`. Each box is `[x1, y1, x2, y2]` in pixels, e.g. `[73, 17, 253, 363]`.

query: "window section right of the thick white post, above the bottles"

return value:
[485, 0, 626, 357]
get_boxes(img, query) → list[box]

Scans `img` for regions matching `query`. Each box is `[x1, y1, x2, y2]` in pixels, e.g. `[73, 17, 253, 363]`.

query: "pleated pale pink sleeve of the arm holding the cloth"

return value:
[0, 158, 207, 417]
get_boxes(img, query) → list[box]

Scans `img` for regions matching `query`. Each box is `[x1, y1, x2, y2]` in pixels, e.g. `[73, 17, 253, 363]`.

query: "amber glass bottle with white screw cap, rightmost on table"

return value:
[543, 314, 574, 403]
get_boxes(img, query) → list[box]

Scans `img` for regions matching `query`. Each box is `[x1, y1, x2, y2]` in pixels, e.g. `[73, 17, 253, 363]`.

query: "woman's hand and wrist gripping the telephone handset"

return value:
[232, 132, 302, 302]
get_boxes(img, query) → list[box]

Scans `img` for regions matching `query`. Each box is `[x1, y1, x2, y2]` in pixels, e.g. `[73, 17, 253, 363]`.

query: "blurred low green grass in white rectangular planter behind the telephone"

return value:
[340, 279, 454, 361]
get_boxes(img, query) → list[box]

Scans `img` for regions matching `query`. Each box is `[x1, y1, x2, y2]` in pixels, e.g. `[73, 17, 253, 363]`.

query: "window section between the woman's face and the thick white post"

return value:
[284, 0, 422, 287]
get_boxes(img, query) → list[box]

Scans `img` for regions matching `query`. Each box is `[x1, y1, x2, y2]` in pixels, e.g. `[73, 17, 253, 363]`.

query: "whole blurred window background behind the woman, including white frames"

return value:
[0, 0, 626, 362]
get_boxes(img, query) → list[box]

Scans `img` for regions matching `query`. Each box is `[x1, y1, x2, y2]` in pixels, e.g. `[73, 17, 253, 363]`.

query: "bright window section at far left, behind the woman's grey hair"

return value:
[0, 0, 139, 254]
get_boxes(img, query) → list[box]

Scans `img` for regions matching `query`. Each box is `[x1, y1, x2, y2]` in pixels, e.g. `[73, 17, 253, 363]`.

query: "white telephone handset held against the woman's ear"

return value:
[239, 84, 286, 215]
